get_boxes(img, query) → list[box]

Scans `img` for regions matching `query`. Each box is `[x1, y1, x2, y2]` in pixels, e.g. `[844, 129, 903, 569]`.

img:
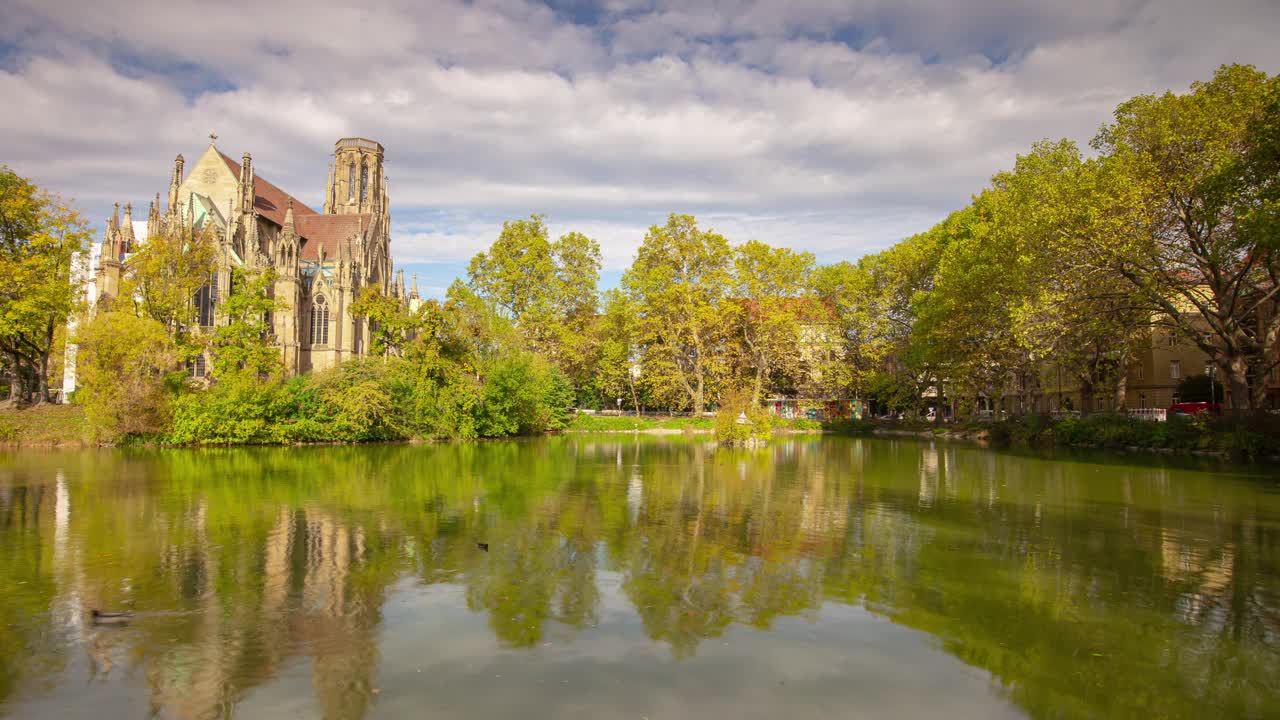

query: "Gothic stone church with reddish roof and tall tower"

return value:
[92, 135, 420, 377]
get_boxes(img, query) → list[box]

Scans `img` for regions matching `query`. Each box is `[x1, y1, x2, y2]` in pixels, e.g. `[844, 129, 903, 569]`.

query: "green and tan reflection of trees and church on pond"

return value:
[0, 438, 1280, 717]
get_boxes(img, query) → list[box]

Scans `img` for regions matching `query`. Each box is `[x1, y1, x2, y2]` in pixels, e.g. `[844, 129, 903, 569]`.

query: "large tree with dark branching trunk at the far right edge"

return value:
[1093, 65, 1280, 409]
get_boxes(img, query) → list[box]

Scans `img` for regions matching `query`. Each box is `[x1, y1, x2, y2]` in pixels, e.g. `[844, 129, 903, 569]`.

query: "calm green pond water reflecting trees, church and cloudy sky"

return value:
[0, 436, 1280, 720]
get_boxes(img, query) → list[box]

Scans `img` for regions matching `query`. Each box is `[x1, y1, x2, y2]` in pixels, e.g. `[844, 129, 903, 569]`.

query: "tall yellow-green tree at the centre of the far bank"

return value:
[622, 214, 732, 415]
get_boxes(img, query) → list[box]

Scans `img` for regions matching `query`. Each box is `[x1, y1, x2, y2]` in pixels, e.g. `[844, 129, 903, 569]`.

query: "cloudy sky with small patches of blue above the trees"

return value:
[0, 0, 1280, 296]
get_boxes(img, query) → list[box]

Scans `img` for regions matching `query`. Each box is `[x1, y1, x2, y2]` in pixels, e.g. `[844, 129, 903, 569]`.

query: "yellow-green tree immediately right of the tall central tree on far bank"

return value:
[733, 240, 822, 405]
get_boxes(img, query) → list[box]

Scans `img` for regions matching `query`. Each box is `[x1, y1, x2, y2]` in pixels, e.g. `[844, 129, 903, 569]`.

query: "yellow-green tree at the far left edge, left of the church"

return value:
[0, 167, 90, 401]
